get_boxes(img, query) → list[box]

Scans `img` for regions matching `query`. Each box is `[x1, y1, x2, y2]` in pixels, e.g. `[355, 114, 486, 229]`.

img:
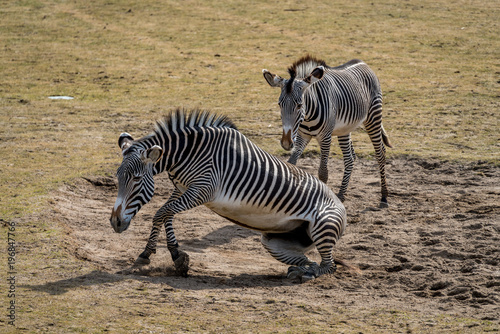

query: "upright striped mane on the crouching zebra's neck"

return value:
[155, 108, 237, 135]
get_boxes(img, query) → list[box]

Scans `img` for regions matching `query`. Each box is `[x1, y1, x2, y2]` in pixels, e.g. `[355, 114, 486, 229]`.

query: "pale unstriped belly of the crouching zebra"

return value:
[205, 201, 307, 233]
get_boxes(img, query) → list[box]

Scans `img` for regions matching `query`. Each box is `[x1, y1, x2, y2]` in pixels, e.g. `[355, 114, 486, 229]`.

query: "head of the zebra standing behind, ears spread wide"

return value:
[262, 66, 325, 151]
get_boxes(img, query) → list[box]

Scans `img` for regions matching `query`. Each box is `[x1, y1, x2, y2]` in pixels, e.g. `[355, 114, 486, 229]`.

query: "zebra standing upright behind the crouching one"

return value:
[262, 55, 392, 207]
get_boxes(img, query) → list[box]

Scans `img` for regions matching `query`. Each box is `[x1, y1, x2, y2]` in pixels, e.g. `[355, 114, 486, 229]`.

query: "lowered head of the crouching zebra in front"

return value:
[110, 133, 163, 233]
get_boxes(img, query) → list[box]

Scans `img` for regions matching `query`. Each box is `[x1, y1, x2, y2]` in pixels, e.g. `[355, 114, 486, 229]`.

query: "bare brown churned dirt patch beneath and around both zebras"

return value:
[53, 157, 500, 324]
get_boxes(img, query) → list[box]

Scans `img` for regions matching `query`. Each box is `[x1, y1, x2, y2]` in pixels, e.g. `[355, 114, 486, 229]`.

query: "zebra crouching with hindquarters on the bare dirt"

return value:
[110, 109, 349, 282]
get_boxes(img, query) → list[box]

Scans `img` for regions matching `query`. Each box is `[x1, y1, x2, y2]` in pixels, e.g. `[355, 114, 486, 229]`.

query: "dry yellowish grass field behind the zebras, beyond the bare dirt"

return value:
[0, 0, 500, 332]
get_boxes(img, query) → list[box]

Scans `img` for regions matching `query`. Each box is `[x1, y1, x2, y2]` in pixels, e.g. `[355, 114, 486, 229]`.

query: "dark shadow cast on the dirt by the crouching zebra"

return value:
[21, 224, 296, 295]
